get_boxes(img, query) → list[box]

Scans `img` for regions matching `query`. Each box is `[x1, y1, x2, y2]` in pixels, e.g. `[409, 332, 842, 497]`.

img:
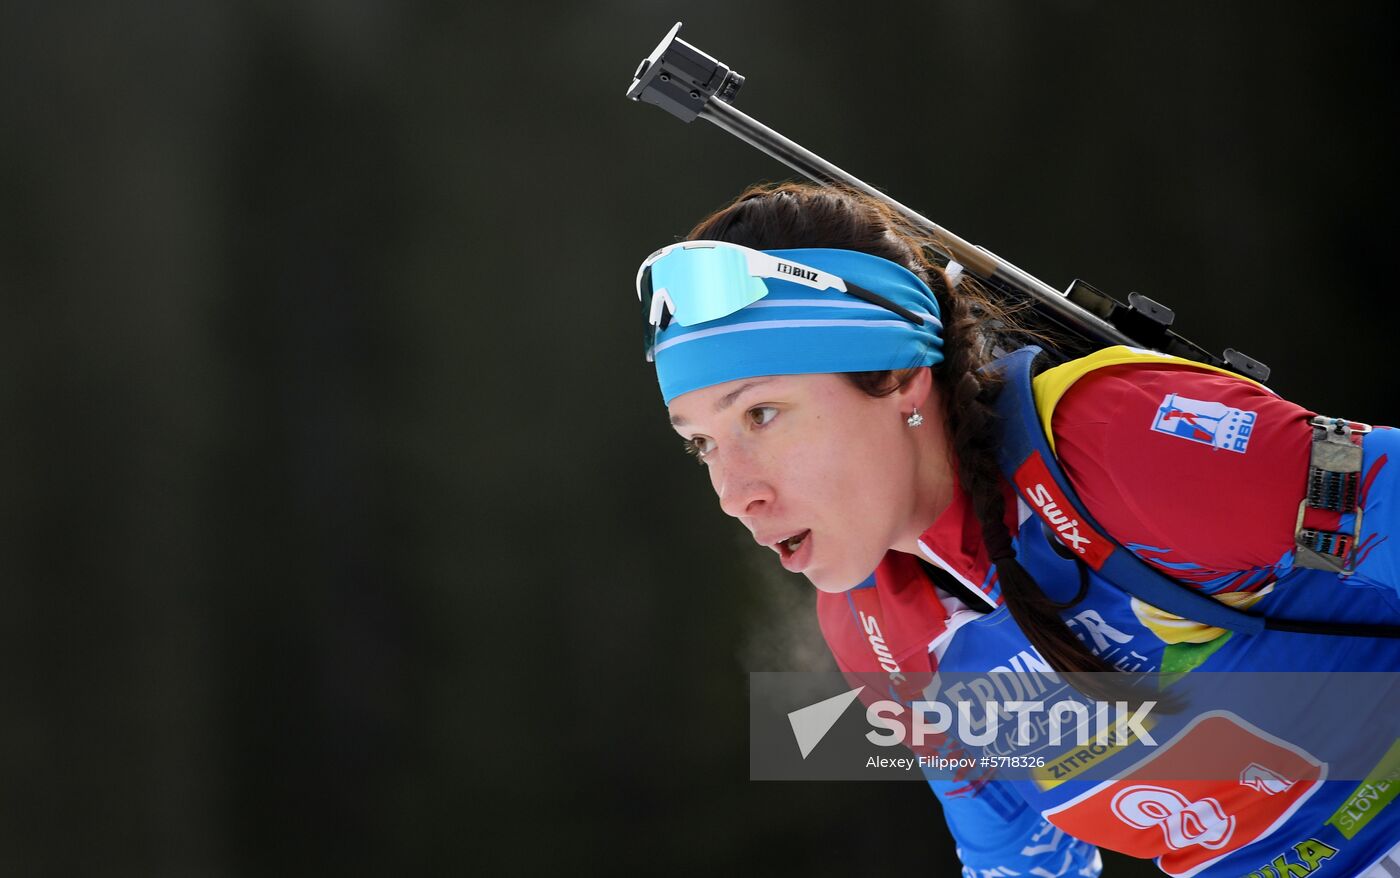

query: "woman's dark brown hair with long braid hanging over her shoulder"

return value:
[686, 182, 1113, 672]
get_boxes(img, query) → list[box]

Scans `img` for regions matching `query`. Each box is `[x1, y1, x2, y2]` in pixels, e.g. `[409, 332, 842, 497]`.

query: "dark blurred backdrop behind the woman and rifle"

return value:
[0, 0, 1400, 875]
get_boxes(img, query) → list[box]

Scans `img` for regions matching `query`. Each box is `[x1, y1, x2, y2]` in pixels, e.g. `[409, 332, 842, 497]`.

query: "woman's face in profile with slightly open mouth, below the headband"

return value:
[671, 368, 951, 592]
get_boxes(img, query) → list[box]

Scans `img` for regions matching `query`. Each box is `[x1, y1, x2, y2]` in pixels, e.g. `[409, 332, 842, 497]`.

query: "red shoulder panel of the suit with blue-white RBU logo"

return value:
[1051, 363, 1313, 592]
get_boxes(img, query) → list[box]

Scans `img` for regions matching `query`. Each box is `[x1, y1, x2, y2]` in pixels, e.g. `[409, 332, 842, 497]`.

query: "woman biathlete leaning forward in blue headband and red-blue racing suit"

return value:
[637, 183, 1400, 878]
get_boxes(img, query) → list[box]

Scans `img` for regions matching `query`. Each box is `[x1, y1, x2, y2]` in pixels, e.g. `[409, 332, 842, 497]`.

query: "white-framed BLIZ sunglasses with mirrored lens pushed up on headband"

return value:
[637, 241, 924, 363]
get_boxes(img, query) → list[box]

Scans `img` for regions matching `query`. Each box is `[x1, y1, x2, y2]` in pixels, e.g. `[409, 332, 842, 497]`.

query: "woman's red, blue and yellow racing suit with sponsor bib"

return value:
[818, 347, 1400, 878]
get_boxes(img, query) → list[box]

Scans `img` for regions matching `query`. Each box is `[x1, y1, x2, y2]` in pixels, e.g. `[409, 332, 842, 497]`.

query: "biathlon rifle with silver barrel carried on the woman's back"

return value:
[627, 21, 1270, 382]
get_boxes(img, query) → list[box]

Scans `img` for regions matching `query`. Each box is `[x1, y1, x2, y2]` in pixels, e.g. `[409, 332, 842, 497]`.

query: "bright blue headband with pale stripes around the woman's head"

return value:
[655, 248, 944, 405]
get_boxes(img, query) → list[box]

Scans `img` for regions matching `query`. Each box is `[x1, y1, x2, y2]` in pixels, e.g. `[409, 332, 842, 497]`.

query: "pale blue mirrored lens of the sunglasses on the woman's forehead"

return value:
[651, 246, 769, 326]
